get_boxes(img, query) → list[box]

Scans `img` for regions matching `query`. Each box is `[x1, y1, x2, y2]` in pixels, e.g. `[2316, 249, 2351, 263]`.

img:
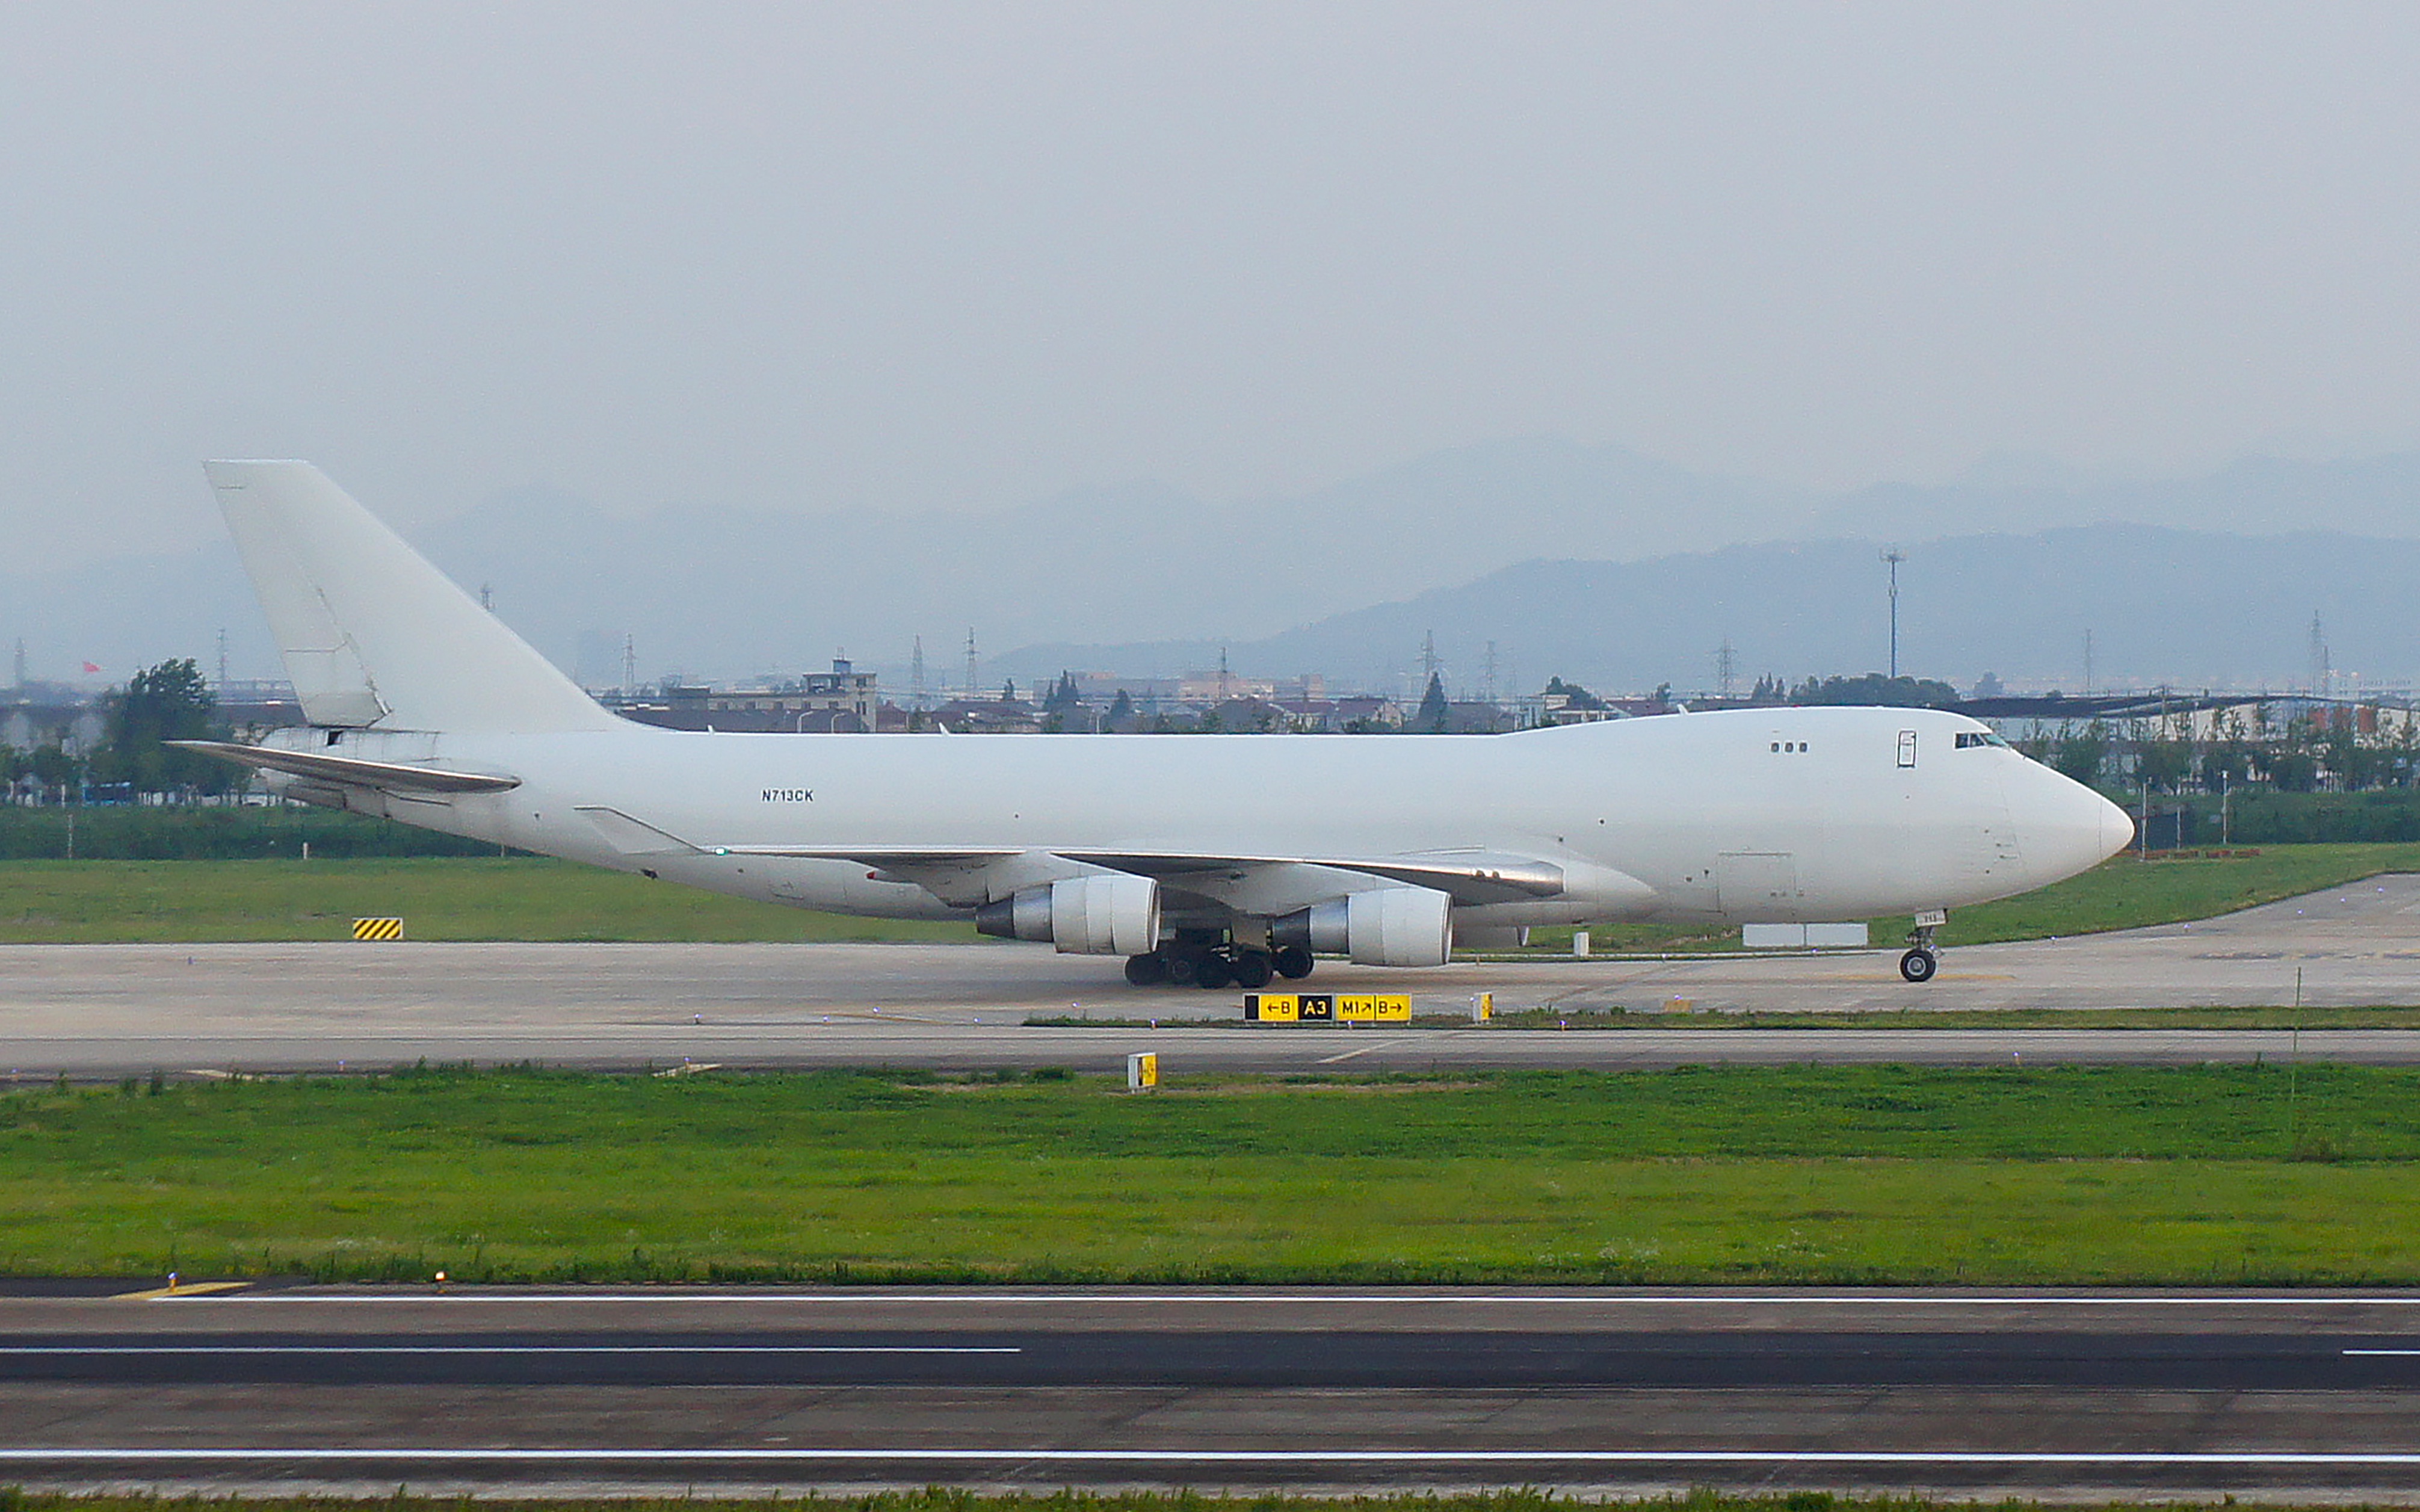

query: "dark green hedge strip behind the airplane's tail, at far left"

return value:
[0, 803, 520, 861]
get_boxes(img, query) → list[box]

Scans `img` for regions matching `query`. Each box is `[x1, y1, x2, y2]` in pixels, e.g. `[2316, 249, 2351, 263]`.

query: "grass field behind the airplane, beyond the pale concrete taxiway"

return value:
[0, 844, 2420, 955]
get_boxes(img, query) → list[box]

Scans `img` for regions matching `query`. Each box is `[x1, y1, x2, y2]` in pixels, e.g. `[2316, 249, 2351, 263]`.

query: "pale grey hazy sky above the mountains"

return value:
[0, 0, 2420, 566]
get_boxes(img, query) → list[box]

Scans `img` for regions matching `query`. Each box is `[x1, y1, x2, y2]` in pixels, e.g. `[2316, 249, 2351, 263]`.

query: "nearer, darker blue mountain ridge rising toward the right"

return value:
[999, 525, 2420, 692]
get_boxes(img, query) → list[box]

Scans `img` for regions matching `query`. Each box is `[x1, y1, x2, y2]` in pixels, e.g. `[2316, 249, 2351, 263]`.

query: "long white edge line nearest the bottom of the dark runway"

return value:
[0, 1444, 2420, 1466]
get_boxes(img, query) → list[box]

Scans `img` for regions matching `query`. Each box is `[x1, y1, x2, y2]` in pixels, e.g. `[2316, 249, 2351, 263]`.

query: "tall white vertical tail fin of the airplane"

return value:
[203, 462, 622, 733]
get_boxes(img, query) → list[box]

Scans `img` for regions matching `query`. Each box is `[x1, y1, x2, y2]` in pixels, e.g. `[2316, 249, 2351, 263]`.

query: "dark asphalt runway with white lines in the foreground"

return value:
[14, 1287, 2420, 1498]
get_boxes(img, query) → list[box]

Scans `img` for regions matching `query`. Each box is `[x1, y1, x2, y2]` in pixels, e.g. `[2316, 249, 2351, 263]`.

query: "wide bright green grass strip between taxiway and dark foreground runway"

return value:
[0, 1064, 2420, 1285]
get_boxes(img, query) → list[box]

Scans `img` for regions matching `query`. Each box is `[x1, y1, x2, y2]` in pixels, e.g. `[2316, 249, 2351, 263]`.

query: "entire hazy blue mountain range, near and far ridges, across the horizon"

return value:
[0, 438, 2420, 690]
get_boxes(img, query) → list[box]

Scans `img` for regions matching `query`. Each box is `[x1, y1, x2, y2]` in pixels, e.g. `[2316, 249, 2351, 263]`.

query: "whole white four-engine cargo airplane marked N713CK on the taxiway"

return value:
[179, 462, 2132, 987]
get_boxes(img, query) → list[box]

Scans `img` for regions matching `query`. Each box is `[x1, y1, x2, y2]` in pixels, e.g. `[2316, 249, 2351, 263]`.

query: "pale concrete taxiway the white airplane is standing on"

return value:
[14, 876, 2420, 1081]
